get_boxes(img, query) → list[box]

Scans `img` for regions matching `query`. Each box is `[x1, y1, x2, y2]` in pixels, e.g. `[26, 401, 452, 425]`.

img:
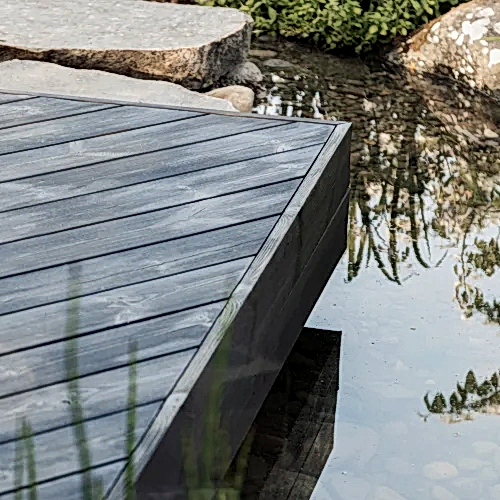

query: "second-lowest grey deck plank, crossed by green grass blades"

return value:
[0, 403, 159, 493]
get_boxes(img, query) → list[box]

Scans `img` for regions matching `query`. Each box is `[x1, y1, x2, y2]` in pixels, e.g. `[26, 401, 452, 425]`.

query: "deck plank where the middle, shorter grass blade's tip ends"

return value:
[0, 302, 224, 400]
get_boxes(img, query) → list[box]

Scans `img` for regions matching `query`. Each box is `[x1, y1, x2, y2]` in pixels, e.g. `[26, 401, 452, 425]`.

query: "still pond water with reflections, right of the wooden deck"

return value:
[236, 38, 500, 500]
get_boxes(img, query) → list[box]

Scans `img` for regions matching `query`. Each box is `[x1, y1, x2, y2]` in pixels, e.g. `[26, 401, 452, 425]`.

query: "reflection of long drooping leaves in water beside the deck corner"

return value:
[348, 137, 444, 284]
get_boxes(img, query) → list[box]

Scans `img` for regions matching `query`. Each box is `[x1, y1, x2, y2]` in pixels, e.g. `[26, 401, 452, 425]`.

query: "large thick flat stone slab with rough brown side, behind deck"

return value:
[0, 0, 252, 89]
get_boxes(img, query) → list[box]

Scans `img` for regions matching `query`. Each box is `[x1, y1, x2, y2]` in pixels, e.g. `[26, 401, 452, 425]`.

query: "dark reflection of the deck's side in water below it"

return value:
[226, 328, 341, 500]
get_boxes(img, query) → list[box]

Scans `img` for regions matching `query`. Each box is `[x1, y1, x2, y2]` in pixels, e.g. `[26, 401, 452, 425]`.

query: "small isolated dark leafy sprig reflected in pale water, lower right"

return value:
[424, 370, 500, 420]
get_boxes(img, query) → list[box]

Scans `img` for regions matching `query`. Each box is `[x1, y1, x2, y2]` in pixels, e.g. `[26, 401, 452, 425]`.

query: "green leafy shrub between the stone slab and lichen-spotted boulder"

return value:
[197, 0, 461, 52]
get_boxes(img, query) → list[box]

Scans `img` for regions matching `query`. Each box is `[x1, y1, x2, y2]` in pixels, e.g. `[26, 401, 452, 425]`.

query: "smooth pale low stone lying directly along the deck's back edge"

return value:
[0, 60, 237, 111]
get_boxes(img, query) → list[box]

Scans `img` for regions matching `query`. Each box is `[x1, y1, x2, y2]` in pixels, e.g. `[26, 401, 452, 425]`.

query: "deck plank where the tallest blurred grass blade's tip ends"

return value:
[0, 217, 277, 314]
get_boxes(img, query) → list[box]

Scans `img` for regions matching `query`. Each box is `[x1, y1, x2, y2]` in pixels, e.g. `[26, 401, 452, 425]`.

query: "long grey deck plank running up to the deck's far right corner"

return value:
[0, 122, 332, 210]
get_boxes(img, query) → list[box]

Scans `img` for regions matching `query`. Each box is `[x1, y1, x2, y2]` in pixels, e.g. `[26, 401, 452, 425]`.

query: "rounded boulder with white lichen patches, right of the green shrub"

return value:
[390, 0, 500, 92]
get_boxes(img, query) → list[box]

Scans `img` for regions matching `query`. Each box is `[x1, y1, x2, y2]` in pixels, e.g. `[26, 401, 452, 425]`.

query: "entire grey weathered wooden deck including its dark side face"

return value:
[0, 93, 350, 500]
